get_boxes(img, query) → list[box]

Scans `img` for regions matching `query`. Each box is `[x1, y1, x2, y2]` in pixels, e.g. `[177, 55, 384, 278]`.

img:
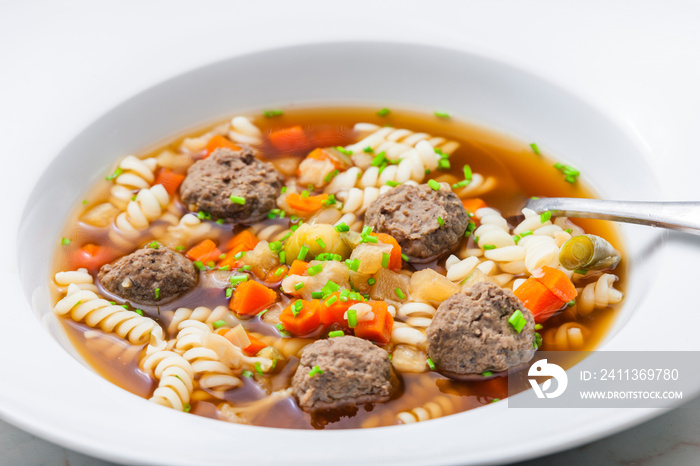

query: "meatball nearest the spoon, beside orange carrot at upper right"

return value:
[365, 183, 469, 258]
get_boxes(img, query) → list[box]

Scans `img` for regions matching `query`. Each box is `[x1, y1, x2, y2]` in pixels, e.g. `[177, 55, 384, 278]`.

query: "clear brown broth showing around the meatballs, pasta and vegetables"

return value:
[53, 108, 626, 429]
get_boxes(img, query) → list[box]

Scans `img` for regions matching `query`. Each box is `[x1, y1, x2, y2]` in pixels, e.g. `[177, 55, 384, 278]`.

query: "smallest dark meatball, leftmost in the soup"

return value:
[97, 245, 199, 305]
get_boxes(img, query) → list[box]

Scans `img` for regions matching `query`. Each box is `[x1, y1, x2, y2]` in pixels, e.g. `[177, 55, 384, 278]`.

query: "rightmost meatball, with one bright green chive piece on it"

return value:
[426, 282, 535, 375]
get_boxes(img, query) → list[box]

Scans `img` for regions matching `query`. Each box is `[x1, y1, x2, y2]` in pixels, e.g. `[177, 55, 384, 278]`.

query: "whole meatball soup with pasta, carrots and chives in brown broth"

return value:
[51, 108, 624, 429]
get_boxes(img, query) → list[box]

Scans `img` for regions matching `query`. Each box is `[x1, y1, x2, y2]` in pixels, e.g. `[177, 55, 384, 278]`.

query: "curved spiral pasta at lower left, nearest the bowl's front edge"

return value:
[141, 350, 194, 411]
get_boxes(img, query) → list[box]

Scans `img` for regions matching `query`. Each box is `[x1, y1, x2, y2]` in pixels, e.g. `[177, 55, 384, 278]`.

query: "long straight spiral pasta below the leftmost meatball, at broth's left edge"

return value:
[54, 284, 163, 345]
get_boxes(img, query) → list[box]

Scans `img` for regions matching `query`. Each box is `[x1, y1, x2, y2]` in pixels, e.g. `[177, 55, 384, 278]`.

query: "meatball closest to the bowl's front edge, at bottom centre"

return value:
[292, 336, 396, 412]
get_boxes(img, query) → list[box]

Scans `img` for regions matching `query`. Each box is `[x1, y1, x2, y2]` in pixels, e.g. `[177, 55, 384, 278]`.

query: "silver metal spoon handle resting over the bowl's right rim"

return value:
[526, 197, 700, 235]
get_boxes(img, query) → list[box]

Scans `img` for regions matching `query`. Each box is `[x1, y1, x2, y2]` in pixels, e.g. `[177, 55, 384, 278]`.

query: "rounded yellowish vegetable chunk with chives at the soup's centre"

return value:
[284, 223, 351, 264]
